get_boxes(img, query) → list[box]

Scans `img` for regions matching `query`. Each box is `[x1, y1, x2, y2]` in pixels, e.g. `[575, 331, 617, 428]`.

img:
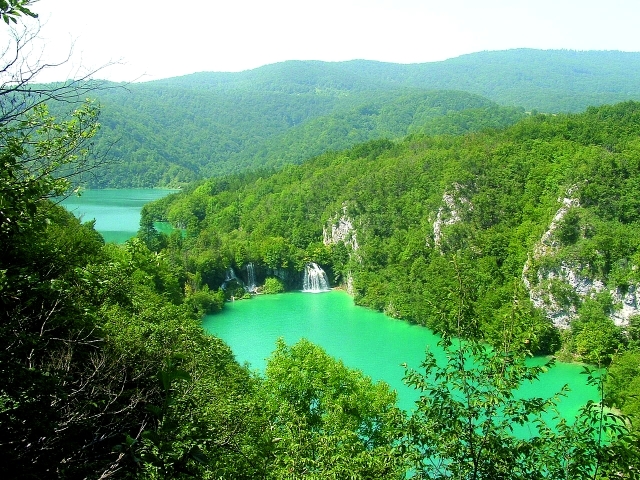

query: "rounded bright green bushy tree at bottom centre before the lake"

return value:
[263, 340, 403, 479]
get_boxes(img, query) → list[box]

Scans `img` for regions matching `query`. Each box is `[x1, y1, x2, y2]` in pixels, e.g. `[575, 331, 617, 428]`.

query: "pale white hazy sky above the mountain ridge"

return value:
[12, 0, 640, 81]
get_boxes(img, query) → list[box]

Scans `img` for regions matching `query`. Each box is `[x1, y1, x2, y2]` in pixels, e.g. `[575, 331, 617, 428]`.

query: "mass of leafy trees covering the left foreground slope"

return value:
[0, 60, 262, 478]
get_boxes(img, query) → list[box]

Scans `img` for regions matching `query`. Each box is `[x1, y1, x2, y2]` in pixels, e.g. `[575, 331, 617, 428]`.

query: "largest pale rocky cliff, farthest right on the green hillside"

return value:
[522, 187, 640, 328]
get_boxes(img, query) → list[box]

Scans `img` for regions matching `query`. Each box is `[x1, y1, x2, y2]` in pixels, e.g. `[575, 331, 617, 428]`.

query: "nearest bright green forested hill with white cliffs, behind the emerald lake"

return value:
[145, 102, 640, 363]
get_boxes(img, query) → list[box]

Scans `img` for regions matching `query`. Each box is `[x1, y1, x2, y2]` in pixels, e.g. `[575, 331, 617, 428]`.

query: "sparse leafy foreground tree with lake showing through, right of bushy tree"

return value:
[404, 337, 553, 479]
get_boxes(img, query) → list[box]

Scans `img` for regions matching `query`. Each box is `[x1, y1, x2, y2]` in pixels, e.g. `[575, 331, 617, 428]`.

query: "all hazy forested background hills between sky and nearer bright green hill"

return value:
[70, 50, 640, 187]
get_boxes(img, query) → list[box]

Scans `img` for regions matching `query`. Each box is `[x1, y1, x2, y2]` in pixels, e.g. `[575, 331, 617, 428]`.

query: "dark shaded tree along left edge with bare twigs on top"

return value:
[0, 4, 141, 478]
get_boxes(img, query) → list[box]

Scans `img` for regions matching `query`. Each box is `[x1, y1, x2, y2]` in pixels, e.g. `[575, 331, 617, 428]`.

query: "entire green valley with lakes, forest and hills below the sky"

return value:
[5, 8, 640, 472]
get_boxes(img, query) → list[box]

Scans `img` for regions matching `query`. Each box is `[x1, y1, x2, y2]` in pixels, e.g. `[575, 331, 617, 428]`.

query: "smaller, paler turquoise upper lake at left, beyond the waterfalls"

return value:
[62, 188, 176, 243]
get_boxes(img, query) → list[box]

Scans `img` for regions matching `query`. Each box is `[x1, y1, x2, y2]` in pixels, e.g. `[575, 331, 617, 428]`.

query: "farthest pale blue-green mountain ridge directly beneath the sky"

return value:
[147, 48, 640, 113]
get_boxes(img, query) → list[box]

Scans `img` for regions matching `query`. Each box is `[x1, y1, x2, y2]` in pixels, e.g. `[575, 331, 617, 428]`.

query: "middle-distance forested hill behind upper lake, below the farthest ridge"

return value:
[89, 85, 524, 188]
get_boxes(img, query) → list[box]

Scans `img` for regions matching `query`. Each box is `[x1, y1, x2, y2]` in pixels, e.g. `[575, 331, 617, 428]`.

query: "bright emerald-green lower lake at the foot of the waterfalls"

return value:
[203, 290, 597, 424]
